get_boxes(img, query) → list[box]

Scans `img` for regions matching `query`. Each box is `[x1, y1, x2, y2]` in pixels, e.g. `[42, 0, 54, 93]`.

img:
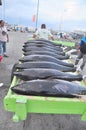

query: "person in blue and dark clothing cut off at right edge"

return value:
[76, 33, 86, 72]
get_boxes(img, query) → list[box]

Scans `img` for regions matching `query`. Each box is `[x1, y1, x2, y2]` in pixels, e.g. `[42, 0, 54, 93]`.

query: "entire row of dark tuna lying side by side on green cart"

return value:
[11, 39, 86, 98]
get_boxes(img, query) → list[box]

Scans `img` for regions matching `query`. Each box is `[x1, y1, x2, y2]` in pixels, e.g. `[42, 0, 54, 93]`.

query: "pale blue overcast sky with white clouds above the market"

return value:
[0, 0, 86, 30]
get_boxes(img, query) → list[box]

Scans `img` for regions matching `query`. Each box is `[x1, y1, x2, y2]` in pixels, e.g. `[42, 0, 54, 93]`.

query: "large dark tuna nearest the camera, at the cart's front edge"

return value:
[11, 80, 86, 98]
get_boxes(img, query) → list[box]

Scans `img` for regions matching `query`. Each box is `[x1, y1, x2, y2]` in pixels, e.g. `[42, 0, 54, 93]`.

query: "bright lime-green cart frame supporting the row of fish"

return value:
[4, 40, 86, 122]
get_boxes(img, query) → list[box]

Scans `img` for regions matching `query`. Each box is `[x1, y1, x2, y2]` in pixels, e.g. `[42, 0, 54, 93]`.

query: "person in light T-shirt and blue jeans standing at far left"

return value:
[0, 20, 9, 57]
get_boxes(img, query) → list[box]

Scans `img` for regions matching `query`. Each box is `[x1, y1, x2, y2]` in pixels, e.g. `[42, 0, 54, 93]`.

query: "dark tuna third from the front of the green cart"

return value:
[16, 61, 76, 72]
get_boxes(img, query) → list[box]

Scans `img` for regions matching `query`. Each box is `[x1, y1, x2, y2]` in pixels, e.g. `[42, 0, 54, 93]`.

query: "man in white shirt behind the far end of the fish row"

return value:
[33, 24, 54, 40]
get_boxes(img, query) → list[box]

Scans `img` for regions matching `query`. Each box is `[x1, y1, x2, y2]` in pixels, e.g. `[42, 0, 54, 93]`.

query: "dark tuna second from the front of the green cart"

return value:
[14, 68, 82, 81]
